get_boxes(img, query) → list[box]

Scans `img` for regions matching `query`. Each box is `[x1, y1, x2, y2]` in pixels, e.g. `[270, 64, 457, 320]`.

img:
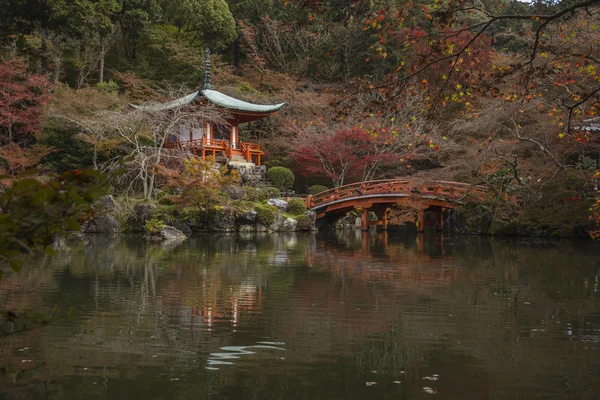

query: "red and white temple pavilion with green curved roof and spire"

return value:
[134, 49, 285, 165]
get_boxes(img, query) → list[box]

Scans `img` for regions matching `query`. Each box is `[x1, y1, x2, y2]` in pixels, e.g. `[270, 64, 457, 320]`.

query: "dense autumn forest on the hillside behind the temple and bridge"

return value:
[0, 0, 600, 236]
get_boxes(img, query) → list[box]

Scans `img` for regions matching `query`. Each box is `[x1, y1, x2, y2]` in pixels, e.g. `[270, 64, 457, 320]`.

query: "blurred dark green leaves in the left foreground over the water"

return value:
[0, 170, 106, 278]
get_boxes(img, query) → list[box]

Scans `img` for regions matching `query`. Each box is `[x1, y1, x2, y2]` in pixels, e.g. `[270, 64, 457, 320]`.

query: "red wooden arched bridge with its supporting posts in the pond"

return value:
[306, 179, 488, 232]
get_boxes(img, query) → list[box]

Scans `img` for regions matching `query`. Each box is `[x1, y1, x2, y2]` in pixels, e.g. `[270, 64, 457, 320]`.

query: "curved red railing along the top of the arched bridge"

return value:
[306, 179, 488, 208]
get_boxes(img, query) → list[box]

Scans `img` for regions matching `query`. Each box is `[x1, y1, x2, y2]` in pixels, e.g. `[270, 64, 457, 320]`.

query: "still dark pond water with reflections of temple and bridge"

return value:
[0, 232, 600, 400]
